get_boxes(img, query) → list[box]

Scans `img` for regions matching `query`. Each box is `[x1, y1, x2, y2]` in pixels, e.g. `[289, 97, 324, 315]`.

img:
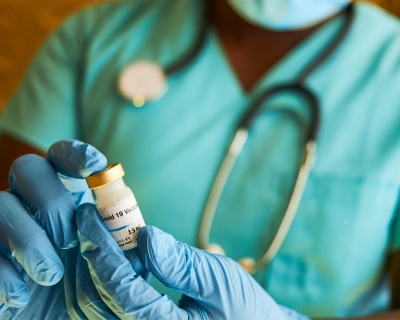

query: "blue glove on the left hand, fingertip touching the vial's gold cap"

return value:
[0, 140, 106, 319]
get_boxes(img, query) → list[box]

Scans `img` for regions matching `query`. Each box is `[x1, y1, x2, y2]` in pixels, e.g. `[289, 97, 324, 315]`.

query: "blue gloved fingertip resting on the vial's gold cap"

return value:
[47, 140, 107, 179]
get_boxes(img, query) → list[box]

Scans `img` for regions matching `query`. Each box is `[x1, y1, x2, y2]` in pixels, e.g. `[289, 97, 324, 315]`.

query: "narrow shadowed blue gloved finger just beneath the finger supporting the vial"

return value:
[76, 250, 118, 319]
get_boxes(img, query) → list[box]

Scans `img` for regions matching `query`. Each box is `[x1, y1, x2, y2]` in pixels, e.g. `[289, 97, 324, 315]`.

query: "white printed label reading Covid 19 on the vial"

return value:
[98, 195, 146, 250]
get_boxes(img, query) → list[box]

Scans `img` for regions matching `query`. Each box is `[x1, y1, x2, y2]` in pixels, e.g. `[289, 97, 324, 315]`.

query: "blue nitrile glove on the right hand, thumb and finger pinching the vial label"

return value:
[76, 204, 309, 320]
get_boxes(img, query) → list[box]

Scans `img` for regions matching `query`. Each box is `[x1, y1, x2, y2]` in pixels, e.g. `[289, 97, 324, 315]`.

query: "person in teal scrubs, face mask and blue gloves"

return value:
[0, 0, 400, 320]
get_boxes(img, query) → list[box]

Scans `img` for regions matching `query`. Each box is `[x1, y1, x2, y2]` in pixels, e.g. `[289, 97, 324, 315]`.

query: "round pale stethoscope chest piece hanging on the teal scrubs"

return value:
[118, 60, 168, 107]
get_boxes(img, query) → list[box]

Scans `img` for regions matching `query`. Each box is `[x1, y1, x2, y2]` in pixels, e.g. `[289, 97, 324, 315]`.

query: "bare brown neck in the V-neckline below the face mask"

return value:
[209, 0, 319, 91]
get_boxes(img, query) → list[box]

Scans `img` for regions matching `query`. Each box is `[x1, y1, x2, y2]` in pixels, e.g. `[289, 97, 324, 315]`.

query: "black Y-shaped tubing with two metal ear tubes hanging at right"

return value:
[198, 4, 354, 273]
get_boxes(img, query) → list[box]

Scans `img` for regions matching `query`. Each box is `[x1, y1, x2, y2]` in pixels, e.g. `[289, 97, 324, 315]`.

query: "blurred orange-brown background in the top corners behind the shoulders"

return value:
[0, 0, 400, 112]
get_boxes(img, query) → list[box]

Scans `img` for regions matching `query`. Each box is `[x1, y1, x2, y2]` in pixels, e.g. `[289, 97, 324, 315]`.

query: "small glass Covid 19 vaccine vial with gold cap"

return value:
[86, 163, 146, 251]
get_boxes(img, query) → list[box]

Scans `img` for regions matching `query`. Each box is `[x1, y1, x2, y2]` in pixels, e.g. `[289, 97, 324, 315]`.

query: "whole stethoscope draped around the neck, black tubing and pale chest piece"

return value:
[119, 4, 354, 273]
